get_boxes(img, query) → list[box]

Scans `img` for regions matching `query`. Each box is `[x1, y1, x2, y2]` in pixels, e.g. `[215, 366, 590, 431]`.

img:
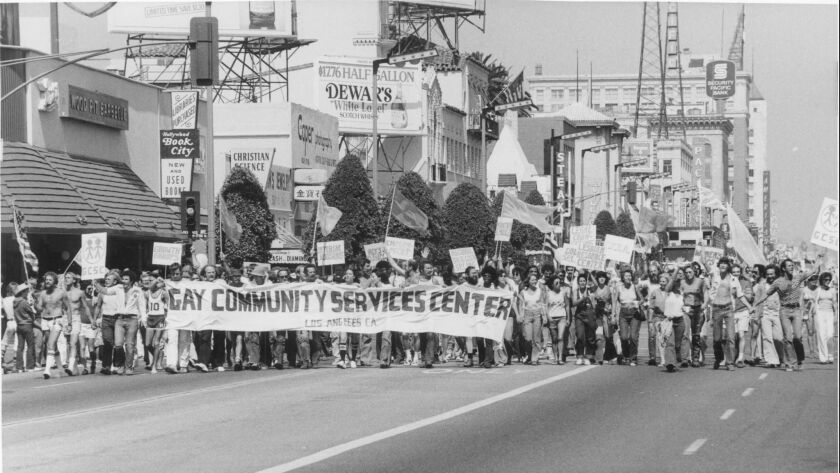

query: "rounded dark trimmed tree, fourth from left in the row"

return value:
[443, 182, 496, 268]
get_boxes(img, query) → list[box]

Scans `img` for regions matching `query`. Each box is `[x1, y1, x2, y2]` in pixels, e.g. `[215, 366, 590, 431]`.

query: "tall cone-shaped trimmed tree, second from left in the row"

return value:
[302, 155, 385, 263]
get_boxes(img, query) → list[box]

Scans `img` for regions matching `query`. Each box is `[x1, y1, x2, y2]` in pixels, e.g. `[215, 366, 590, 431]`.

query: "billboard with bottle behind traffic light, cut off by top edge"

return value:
[108, 1, 294, 38]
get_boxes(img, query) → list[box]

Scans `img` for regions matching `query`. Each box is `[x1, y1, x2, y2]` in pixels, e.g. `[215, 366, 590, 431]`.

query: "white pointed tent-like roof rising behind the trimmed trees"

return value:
[487, 110, 539, 192]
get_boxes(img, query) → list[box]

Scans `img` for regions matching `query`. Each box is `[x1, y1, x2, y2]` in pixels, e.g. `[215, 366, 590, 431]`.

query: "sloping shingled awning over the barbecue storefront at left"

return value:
[0, 139, 183, 236]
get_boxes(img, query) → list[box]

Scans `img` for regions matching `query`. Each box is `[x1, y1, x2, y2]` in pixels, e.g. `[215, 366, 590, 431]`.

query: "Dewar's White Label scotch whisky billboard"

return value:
[315, 57, 423, 136]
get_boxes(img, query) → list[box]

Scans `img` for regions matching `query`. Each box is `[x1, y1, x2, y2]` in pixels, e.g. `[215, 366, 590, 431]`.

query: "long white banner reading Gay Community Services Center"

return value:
[166, 281, 511, 341]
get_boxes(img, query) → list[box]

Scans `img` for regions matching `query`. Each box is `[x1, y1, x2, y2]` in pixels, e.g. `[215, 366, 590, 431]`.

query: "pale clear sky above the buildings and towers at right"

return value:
[460, 0, 838, 241]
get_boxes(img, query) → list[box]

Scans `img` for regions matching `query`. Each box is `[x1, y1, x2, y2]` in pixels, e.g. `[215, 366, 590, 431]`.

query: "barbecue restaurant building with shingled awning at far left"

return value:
[0, 48, 183, 282]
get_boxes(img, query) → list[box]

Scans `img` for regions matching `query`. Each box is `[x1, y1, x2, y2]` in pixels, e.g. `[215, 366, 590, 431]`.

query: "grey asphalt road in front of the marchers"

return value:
[2, 344, 838, 473]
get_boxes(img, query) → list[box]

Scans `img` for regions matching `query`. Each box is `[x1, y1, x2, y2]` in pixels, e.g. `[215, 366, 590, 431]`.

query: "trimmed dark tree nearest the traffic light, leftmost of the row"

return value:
[215, 167, 277, 268]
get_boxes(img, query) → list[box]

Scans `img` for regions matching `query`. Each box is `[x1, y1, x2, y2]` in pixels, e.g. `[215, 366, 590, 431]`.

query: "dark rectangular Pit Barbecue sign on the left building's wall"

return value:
[60, 84, 128, 130]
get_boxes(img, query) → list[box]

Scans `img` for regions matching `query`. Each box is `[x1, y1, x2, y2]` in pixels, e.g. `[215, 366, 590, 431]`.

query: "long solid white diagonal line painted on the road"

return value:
[258, 365, 597, 473]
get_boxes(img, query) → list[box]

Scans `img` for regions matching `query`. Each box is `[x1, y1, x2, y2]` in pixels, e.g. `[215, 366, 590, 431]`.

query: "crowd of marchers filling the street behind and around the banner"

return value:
[2, 257, 838, 379]
